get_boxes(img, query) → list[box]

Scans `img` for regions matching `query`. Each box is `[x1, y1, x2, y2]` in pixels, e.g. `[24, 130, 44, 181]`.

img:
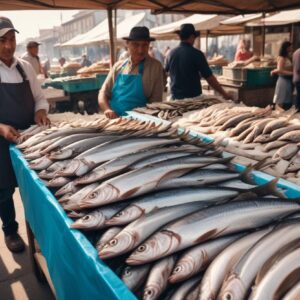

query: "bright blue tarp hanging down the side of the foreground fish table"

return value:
[10, 146, 136, 300]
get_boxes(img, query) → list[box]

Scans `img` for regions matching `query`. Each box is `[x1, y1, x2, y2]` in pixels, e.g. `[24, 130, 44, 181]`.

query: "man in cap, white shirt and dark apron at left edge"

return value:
[0, 17, 49, 252]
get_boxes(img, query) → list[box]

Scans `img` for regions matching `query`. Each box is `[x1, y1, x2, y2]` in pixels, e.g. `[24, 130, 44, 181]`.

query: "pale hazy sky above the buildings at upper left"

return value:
[0, 10, 78, 43]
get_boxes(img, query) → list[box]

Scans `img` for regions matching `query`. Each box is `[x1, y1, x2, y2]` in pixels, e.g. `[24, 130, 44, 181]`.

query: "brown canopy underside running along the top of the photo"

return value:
[0, 0, 300, 14]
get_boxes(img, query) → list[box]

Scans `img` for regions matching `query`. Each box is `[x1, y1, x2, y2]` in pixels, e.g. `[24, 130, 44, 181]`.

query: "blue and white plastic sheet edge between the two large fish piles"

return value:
[128, 112, 300, 198]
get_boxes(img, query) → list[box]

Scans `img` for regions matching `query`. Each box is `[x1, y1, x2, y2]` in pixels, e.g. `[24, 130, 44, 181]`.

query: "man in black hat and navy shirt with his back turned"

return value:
[165, 24, 230, 100]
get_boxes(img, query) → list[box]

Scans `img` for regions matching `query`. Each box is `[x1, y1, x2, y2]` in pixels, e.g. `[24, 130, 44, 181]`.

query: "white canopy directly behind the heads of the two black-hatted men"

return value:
[150, 14, 227, 39]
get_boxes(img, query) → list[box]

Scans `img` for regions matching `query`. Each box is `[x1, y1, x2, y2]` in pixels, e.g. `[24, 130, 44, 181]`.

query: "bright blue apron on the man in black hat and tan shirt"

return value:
[109, 60, 147, 116]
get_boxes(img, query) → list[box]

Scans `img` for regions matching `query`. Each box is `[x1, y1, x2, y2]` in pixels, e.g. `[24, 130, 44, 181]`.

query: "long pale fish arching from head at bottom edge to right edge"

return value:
[219, 221, 300, 300]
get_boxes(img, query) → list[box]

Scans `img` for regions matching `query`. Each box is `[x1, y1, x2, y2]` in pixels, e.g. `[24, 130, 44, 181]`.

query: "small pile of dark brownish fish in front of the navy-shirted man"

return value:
[134, 97, 223, 120]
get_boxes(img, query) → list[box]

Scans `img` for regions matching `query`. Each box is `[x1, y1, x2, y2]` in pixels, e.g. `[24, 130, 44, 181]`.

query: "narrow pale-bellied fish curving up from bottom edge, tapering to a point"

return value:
[199, 229, 270, 300]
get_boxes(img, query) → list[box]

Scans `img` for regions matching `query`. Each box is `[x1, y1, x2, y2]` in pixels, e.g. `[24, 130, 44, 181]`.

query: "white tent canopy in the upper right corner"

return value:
[246, 9, 300, 26]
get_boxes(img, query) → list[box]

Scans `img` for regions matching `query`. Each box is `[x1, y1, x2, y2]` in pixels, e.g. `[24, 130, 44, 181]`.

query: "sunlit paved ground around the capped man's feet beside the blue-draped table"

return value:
[0, 192, 54, 300]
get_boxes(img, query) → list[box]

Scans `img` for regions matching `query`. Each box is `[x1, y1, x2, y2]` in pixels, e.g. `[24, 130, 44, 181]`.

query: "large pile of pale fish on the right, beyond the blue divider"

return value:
[174, 103, 300, 184]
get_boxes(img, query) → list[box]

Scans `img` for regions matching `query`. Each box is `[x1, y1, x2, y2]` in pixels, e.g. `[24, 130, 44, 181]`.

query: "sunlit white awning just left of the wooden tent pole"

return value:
[61, 19, 108, 47]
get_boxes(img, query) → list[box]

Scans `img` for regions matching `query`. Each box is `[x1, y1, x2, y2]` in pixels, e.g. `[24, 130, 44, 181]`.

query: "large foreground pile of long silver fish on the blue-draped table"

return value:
[18, 119, 300, 300]
